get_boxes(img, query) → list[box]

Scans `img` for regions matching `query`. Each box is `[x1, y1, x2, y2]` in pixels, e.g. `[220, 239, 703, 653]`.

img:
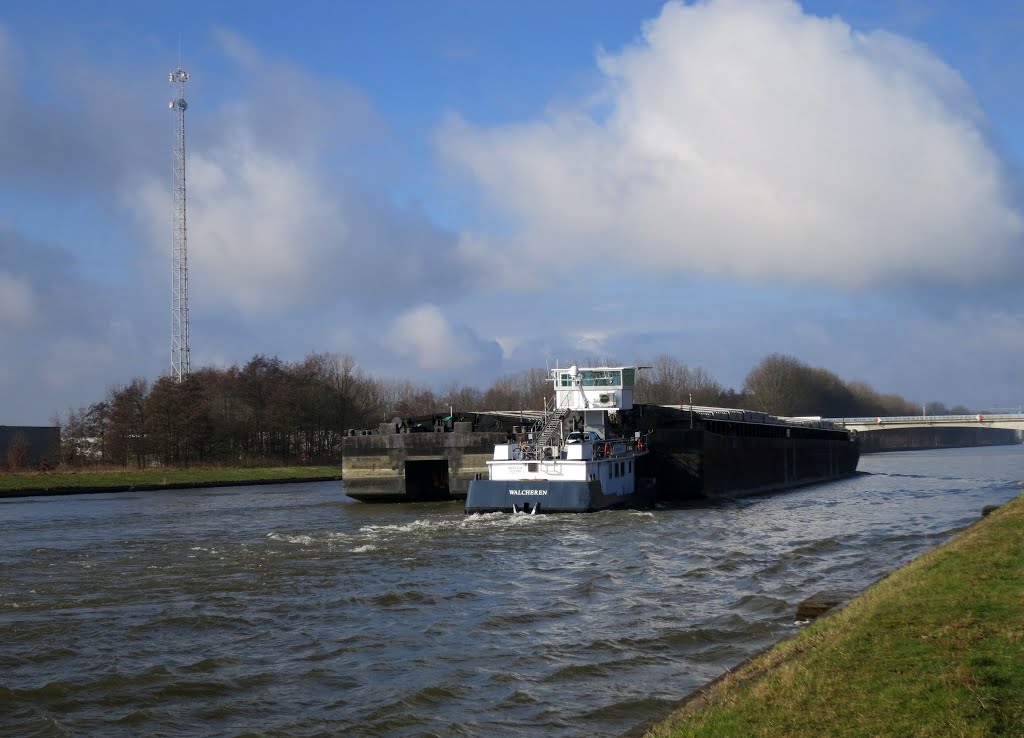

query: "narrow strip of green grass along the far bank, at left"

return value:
[0, 466, 341, 495]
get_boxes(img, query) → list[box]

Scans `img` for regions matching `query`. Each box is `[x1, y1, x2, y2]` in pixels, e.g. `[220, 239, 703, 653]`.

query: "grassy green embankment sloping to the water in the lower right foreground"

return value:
[647, 489, 1024, 738]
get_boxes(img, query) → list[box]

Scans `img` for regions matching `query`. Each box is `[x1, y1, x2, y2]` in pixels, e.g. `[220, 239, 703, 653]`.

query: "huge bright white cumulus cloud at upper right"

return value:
[437, 0, 1024, 291]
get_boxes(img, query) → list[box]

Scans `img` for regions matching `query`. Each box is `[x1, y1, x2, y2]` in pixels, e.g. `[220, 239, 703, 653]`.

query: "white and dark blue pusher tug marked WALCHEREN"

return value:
[466, 366, 654, 513]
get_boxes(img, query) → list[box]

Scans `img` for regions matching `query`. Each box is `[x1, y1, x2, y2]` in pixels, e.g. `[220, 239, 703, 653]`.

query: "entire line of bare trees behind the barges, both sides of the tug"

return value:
[56, 353, 968, 467]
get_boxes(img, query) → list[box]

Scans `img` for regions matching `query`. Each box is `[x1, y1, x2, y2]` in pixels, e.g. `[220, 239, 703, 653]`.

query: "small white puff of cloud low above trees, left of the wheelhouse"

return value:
[386, 304, 501, 372]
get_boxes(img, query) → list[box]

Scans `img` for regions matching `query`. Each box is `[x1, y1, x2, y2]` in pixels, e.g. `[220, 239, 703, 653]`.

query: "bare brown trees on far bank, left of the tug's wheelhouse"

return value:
[55, 353, 550, 468]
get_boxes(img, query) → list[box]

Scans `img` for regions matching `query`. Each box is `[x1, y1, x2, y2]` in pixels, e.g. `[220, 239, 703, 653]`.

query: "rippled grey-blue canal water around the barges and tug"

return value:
[0, 446, 1024, 736]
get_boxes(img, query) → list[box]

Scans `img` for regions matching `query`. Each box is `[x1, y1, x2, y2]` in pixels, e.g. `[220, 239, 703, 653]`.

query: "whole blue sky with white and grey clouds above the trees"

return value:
[0, 0, 1024, 425]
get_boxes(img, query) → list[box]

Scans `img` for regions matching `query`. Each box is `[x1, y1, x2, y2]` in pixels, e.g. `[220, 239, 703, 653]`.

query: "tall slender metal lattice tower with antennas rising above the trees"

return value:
[168, 67, 188, 382]
